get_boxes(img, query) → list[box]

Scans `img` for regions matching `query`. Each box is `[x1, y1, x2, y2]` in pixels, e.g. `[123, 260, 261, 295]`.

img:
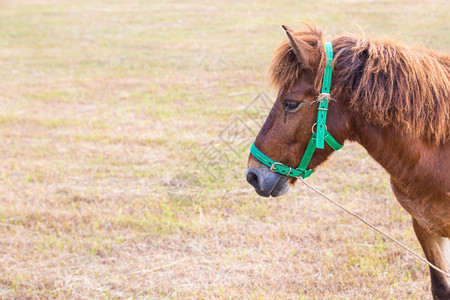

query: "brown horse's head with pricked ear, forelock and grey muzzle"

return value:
[246, 26, 348, 197]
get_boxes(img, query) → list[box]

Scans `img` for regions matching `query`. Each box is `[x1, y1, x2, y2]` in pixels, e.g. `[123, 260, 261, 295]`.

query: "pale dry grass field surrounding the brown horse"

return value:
[0, 0, 450, 299]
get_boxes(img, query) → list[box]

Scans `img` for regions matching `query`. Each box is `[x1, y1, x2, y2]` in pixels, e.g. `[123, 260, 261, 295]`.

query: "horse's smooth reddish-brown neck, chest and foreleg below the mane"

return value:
[350, 98, 450, 299]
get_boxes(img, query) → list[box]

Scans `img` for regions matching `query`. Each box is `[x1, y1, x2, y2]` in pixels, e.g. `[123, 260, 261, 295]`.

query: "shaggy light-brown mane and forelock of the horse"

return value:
[270, 26, 450, 144]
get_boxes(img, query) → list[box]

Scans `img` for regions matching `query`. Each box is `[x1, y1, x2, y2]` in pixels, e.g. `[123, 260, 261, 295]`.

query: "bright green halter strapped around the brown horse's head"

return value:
[250, 42, 343, 178]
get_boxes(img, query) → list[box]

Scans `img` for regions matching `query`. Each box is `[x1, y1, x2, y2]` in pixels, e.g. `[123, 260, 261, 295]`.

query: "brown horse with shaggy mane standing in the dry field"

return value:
[247, 26, 450, 299]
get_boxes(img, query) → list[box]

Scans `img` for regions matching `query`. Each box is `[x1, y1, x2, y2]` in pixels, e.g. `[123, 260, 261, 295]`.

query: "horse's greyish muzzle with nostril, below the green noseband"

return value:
[246, 164, 289, 197]
